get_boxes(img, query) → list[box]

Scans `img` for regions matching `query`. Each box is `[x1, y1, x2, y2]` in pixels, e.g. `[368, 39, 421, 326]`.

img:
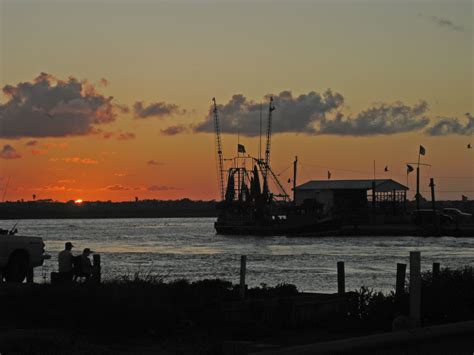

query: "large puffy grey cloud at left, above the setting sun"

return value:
[0, 73, 123, 138]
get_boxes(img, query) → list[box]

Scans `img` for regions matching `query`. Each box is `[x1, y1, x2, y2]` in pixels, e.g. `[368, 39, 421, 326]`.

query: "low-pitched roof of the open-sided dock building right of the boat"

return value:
[296, 179, 409, 192]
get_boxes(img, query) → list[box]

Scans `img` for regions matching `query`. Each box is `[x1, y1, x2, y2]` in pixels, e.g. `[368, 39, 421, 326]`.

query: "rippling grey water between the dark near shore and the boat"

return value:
[0, 218, 474, 292]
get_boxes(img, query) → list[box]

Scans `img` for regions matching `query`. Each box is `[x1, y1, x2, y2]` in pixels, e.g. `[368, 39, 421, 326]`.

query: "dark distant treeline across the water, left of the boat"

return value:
[0, 199, 217, 219]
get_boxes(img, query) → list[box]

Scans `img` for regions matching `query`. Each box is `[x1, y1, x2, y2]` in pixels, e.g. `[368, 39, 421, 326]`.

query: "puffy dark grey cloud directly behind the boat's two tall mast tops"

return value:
[194, 90, 344, 136]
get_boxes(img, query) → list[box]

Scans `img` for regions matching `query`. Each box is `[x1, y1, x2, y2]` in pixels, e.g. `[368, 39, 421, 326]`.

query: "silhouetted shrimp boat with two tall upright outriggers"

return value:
[213, 98, 338, 236]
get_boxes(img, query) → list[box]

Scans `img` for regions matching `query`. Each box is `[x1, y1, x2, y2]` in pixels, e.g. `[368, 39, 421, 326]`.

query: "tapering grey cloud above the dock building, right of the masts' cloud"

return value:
[317, 101, 430, 136]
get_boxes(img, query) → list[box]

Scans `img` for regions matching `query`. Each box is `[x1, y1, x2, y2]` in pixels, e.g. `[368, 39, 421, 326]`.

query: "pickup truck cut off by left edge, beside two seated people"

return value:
[0, 229, 49, 282]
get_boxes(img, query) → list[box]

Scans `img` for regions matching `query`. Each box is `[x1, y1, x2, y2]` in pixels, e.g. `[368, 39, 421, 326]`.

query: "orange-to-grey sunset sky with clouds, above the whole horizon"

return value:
[0, 0, 474, 201]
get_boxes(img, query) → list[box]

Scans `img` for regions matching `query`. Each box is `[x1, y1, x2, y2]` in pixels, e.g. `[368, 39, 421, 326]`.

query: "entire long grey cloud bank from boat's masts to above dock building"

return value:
[194, 90, 430, 136]
